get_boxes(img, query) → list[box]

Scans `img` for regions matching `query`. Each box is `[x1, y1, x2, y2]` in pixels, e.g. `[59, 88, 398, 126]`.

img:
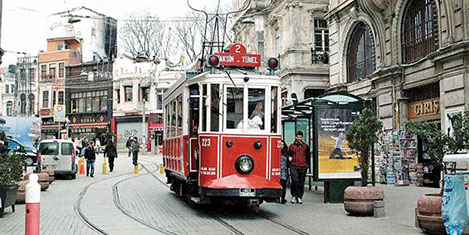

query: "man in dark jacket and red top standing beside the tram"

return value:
[289, 131, 310, 204]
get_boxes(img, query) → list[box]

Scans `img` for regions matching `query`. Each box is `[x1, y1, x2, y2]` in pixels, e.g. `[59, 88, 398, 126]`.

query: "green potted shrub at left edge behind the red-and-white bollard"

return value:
[0, 153, 24, 218]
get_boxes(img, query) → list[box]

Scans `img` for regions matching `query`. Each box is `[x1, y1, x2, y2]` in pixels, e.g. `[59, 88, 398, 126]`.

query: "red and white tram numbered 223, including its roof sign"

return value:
[163, 44, 282, 204]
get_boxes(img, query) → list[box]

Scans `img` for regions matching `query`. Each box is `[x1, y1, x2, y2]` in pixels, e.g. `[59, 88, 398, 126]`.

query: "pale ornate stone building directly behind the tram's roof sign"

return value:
[233, 0, 329, 104]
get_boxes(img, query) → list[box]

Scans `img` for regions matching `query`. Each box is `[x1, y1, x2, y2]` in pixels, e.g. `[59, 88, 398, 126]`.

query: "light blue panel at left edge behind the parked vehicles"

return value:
[0, 117, 41, 147]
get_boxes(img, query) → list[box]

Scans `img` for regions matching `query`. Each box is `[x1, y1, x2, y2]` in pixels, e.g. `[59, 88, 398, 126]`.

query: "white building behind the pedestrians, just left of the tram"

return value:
[113, 56, 184, 151]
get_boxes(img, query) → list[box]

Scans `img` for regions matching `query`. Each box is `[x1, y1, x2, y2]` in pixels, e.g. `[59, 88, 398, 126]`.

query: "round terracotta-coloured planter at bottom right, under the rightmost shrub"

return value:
[416, 194, 446, 234]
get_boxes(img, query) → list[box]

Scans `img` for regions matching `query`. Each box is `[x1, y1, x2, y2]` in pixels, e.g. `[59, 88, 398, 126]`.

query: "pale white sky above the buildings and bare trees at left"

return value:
[1, 0, 232, 66]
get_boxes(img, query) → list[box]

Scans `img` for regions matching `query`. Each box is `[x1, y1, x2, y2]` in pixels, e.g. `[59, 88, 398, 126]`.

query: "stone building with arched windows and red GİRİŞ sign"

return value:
[326, 0, 469, 130]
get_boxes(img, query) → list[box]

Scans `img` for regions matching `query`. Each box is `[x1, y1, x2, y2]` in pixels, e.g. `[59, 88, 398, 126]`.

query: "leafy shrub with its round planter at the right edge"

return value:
[406, 112, 469, 234]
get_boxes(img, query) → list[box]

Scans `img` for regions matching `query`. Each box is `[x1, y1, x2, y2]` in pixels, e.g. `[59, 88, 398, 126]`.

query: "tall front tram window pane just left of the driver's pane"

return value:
[226, 87, 244, 129]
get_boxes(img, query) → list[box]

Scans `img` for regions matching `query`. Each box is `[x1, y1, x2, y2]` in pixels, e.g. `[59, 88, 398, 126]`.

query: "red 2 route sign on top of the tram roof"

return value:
[215, 43, 261, 67]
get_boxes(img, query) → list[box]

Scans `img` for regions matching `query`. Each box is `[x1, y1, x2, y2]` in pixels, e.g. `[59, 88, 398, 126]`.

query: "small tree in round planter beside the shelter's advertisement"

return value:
[344, 108, 384, 215]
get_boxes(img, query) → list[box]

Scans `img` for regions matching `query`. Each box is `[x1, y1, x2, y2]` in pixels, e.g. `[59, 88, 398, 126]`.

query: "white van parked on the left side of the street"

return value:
[39, 140, 77, 179]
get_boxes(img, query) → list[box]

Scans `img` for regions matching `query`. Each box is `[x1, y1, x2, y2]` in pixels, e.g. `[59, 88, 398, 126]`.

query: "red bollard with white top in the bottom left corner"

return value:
[25, 174, 41, 235]
